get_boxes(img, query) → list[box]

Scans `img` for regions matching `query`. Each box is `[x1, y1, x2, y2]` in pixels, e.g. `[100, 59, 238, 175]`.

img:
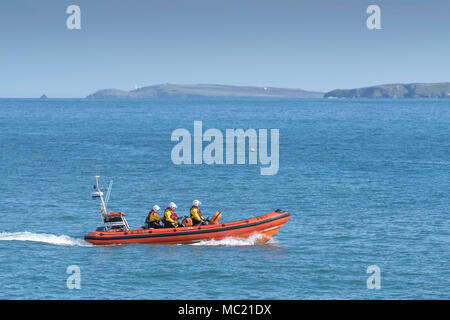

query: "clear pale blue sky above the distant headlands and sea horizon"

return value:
[0, 0, 450, 97]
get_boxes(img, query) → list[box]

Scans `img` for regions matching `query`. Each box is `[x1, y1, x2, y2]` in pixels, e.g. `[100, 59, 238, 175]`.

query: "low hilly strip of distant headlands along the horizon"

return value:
[86, 82, 450, 99]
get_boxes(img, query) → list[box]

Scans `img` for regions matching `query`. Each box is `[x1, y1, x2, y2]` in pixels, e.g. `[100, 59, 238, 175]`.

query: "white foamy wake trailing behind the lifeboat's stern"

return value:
[0, 231, 93, 247]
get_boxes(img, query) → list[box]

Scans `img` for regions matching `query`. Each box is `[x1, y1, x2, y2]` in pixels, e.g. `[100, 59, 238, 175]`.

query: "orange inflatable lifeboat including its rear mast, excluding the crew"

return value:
[84, 176, 290, 245]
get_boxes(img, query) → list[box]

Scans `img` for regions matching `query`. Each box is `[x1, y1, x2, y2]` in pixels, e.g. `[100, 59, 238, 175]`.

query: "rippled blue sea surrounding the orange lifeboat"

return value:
[0, 99, 450, 300]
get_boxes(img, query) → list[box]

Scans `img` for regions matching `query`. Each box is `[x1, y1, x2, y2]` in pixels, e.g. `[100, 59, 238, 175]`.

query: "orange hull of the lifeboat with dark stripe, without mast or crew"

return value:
[84, 210, 290, 245]
